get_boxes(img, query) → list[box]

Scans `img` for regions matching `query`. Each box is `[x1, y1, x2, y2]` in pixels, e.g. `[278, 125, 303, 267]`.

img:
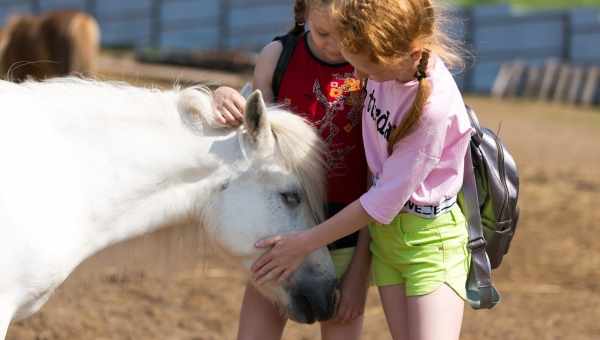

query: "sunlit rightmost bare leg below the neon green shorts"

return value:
[408, 284, 464, 340]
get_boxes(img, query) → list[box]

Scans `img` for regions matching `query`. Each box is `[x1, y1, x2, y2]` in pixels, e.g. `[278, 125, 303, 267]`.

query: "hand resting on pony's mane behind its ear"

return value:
[213, 86, 246, 126]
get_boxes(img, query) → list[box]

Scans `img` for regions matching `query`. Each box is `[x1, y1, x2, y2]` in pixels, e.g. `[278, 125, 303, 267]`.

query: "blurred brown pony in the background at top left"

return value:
[0, 11, 100, 82]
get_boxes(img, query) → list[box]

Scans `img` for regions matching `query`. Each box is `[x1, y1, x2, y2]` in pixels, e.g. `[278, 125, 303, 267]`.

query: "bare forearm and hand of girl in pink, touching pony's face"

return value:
[252, 200, 371, 284]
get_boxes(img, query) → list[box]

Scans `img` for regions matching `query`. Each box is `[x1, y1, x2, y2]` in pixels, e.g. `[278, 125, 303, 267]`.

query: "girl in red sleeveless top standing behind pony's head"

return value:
[215, 0, 370, 340]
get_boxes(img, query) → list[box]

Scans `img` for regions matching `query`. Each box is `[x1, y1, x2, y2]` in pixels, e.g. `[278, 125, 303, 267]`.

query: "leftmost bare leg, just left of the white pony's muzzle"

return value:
[237, 283, 287, 340]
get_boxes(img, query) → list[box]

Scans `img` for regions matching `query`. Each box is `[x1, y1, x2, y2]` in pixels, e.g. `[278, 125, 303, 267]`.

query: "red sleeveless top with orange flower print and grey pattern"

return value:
[278, 34, 367, 205]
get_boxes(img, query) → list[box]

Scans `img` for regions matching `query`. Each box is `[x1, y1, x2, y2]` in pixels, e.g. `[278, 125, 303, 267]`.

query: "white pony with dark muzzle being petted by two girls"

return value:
[0, 78, 335, 339]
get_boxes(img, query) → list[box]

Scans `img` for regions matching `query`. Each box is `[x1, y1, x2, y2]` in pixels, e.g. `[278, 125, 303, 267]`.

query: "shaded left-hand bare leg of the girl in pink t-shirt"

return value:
[379, 284, 412, 340]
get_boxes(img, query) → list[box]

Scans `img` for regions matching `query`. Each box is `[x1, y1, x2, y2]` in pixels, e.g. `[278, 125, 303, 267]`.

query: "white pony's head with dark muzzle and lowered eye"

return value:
[193, 91, 336, 323]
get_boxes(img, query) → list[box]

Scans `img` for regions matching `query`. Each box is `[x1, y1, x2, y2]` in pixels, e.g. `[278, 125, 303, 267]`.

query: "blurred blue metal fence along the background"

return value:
[0, 0, 600, 93]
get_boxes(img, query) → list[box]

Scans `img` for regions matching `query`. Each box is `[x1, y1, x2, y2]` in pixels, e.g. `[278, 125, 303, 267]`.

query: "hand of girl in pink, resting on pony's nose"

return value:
[251, 231, 311, 285]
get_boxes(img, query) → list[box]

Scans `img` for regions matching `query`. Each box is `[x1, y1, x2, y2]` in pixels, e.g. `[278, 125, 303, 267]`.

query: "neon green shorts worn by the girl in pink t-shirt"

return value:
[369, 204, 471, 300]
